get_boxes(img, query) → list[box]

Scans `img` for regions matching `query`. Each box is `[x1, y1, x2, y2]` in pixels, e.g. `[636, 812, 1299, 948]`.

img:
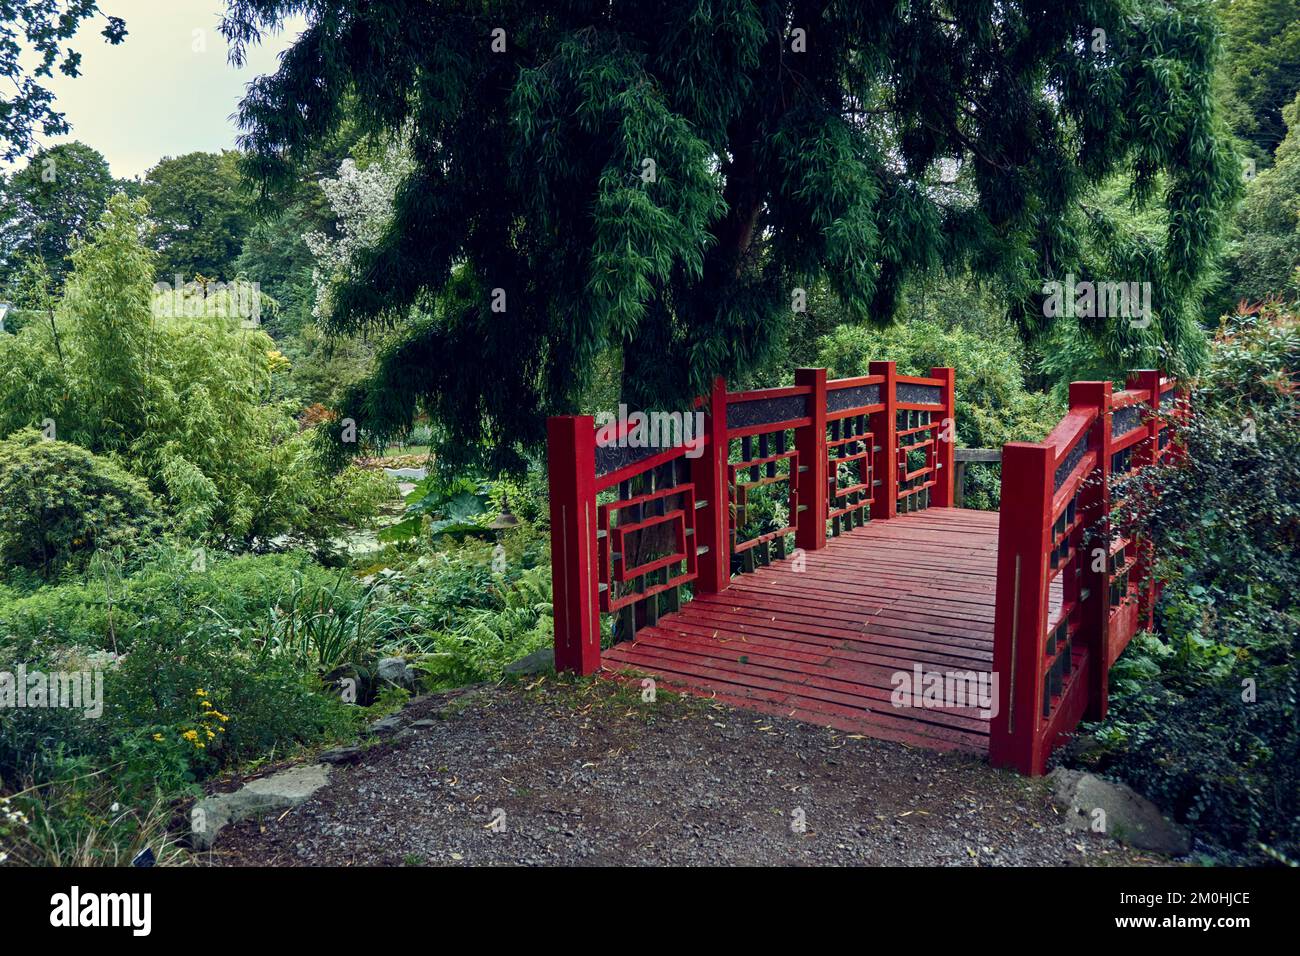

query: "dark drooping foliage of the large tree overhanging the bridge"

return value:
[224, 0, 1238, 471]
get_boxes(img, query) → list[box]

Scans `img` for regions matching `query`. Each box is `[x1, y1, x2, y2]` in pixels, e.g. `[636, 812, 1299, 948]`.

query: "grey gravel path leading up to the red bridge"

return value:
[199, 676, 1164, 866]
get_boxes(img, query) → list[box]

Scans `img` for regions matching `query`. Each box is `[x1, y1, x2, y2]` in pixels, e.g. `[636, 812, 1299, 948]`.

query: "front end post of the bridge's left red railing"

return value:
[546, 415, 601, 674]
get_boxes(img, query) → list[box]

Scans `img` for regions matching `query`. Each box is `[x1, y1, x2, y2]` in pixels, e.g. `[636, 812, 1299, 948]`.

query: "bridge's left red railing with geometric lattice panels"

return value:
[547, 362, 956, 674]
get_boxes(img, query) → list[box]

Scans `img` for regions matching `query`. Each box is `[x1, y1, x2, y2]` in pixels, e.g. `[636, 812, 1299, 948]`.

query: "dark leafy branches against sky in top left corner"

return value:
[0, 0, 126, 161]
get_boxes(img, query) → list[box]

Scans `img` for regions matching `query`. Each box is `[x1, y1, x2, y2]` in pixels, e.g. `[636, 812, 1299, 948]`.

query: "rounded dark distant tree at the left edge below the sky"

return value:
[0, 142, 117, 285]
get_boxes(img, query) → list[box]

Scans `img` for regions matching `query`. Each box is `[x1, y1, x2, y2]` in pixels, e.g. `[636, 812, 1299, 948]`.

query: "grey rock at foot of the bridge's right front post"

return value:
[1048, 767, 1192, 856]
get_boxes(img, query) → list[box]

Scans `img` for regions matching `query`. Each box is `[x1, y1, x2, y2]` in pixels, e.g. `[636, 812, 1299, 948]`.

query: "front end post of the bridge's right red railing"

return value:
[988, 442, 1056, 775]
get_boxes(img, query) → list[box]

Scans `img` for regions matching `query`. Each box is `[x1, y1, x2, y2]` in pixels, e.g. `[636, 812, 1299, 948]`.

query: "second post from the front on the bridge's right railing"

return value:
[1070, 381, 1112, 721]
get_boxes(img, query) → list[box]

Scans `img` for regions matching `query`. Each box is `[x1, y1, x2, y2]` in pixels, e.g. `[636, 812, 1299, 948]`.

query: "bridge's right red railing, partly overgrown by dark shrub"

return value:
[989, 371, 1175, 774]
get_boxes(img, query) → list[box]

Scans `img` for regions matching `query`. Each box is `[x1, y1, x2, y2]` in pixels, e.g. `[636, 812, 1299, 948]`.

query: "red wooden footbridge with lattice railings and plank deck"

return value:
[549, 362, 1175, 774]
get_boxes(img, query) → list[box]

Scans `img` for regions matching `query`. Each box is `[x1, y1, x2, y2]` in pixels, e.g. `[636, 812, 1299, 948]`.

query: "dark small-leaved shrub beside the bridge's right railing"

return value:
[1086, 308, 1300, 860]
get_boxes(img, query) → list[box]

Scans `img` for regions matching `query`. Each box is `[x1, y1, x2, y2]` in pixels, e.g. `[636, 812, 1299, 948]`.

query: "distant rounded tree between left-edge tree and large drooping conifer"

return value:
[142, 150, 252, 282]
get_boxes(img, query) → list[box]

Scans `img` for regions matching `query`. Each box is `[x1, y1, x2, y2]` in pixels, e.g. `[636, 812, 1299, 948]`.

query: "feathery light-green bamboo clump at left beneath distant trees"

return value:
[0, 195, 391, 550]
